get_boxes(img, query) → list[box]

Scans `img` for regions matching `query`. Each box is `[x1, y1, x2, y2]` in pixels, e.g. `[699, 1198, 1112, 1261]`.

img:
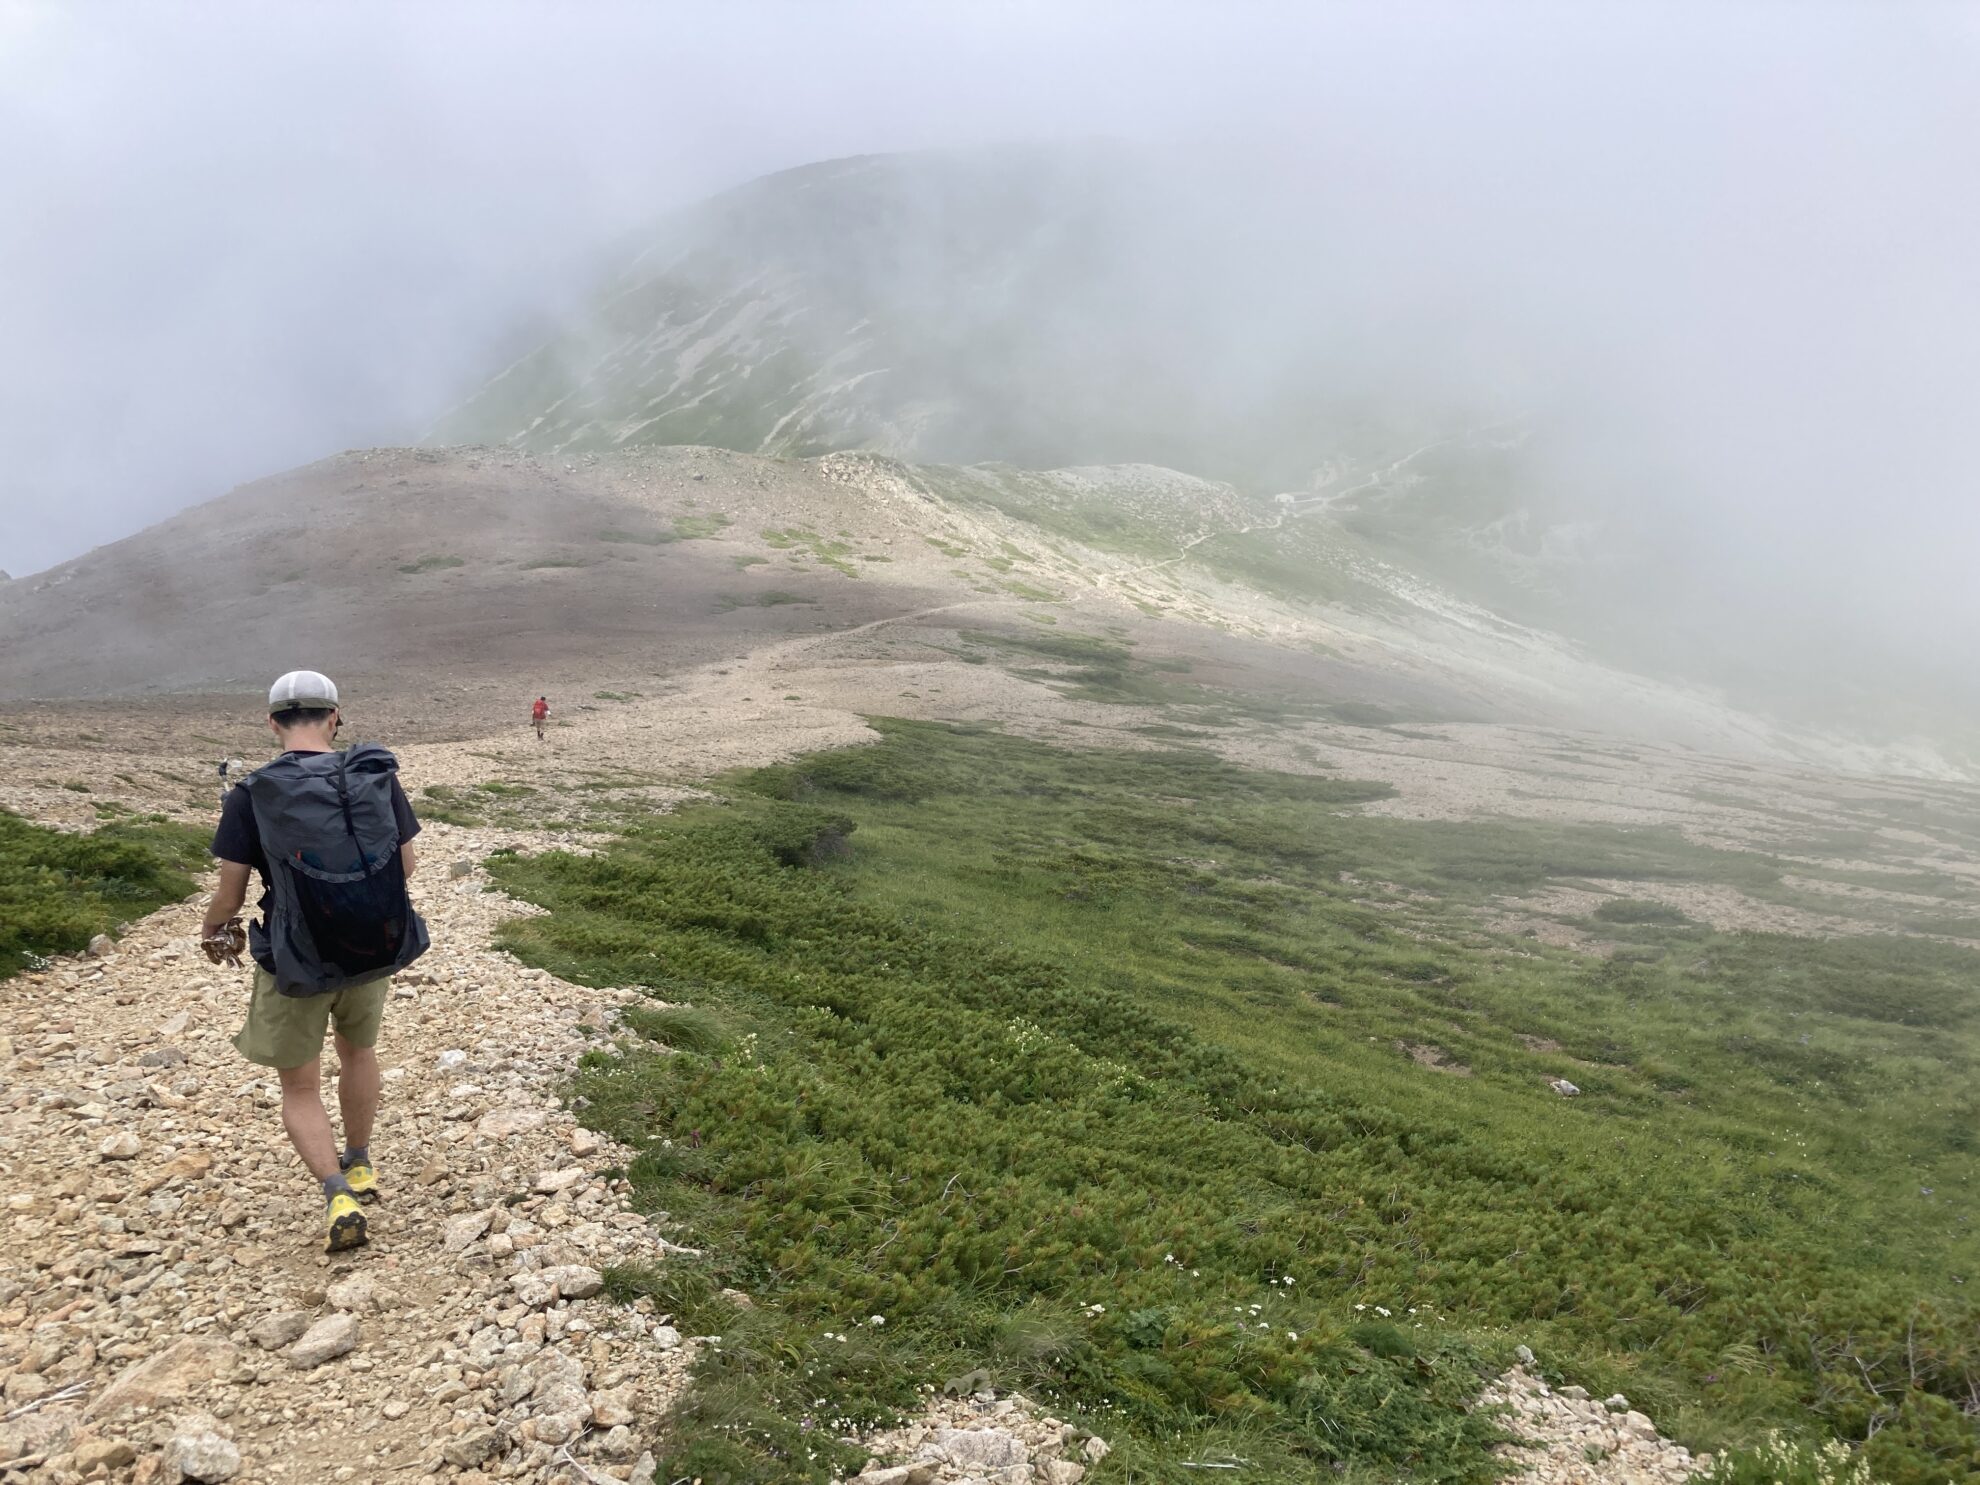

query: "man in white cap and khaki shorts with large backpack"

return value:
[200, 671, 428, 1253]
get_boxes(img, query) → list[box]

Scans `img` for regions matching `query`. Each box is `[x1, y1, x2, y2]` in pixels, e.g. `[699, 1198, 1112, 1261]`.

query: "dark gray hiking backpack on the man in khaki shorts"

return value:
[242, 743, 428, 996]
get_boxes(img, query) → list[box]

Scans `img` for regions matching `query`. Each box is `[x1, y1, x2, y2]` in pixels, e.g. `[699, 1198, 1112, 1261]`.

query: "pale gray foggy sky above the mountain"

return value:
[0, 0, 1980, 704]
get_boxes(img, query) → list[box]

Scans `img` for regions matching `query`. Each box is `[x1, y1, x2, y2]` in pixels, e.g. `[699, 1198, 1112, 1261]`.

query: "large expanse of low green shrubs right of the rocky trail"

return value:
[493, 728, 1980, 1485]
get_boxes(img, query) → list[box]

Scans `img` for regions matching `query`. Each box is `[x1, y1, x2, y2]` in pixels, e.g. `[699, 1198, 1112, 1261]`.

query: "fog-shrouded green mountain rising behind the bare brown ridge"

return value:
[417, 149, 1980, 756]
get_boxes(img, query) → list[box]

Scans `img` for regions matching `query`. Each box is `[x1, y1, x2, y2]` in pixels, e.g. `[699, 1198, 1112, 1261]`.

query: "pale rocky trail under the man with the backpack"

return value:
[0, 826, 695, 1485]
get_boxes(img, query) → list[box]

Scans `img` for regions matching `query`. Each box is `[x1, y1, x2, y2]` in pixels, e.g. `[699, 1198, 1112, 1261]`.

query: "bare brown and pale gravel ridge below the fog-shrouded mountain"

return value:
[0, 447, 1956, 776]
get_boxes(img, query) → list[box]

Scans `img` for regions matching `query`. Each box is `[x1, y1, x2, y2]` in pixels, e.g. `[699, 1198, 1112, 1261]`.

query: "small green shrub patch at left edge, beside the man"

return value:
[0, 810, 206, 978]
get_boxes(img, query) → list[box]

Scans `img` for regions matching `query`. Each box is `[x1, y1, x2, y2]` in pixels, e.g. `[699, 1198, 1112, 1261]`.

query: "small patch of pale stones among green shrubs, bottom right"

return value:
[1479, 1350, 1711, 1485]
